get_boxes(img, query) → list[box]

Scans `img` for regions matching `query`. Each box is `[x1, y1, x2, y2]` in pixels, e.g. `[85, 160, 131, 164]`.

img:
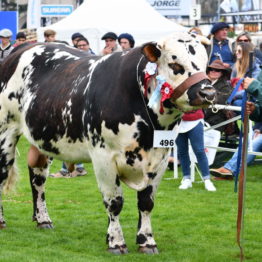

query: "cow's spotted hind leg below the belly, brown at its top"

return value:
[28, 146, 53, 228]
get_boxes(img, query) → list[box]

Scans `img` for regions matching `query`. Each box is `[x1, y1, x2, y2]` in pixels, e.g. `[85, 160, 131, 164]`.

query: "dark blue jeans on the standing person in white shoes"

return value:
[176, 122, 210, 179]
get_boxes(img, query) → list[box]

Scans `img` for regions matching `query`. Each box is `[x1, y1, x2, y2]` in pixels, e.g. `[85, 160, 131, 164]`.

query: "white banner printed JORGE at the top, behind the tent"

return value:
[147, 0, 192, 16]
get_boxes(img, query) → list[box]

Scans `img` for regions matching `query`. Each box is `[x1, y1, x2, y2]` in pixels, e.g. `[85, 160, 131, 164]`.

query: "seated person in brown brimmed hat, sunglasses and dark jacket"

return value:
[205, 59, 238, 135]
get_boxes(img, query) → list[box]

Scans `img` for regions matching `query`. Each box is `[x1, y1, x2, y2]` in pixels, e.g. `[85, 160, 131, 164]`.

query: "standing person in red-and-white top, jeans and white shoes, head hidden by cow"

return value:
[176, 109, 216, 191]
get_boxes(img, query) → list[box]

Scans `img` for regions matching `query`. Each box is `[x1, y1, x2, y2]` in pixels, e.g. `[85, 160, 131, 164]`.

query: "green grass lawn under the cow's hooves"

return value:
[0, 138, 262, 262]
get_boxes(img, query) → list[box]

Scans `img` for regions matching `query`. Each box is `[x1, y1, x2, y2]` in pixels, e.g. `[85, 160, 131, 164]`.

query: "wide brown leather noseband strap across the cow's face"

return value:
[171, 72, 208, 102]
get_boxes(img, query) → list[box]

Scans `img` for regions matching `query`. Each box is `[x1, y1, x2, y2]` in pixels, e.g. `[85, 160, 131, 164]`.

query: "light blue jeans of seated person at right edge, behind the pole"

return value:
[224, 135, 262, 173]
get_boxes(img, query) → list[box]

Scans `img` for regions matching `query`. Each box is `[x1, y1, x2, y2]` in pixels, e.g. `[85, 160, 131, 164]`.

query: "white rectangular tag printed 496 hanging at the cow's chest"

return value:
[154, 130, 176, 148]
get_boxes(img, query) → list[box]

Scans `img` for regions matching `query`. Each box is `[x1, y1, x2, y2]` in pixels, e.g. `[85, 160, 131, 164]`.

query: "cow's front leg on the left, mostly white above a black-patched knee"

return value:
[94, 162, 128, 254]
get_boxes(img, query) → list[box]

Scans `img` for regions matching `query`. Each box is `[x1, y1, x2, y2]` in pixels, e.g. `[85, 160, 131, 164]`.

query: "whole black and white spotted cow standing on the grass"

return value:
[0, 33, 215, 254]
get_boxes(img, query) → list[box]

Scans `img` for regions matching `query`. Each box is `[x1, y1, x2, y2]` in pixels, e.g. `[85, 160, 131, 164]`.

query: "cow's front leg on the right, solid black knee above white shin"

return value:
[136, 185, 158, 254]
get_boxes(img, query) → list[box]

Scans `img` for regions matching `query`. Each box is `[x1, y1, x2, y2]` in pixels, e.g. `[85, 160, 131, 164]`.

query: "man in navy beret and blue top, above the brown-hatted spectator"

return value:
[207, 22, 235, 67]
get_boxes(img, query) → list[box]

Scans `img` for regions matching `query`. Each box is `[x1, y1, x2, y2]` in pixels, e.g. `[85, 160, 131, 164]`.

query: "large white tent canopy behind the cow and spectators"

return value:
[37, 0, 186, 53]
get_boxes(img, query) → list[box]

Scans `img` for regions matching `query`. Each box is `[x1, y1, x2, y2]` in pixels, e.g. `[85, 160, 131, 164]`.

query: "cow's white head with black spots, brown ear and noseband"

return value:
[142, 33, 215, 111]
